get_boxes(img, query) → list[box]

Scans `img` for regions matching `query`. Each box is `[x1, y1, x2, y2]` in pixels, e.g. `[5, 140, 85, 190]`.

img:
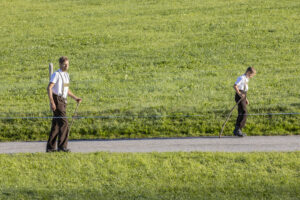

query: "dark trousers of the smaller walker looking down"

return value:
[235, 91, 248, 129]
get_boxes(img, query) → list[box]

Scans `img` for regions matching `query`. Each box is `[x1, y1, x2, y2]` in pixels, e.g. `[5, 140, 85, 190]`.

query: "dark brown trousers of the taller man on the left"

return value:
[47, 94, 69, 150]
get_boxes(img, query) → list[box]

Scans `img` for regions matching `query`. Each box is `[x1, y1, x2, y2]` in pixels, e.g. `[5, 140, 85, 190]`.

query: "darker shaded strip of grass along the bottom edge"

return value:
[0, 183, 299, 200]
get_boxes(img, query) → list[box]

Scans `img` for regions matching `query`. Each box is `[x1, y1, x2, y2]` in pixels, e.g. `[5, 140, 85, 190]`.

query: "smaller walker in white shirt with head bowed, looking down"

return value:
[233, 67, 256, 137]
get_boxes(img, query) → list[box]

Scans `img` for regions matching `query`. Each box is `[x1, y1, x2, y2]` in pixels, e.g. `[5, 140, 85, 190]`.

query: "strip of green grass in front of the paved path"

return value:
[0, 152, 300, 200]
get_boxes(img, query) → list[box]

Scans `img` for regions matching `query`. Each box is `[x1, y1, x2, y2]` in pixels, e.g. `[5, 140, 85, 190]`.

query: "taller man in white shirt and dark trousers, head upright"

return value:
[46, 56, 82, 152]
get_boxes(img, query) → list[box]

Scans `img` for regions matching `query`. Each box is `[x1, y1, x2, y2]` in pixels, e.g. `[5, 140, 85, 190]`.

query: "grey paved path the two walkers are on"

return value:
[0, 136, 300, 153]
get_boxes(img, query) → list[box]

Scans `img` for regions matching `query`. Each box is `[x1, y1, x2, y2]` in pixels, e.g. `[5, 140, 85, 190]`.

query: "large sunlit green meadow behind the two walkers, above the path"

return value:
[0, 0, 300, 141]
